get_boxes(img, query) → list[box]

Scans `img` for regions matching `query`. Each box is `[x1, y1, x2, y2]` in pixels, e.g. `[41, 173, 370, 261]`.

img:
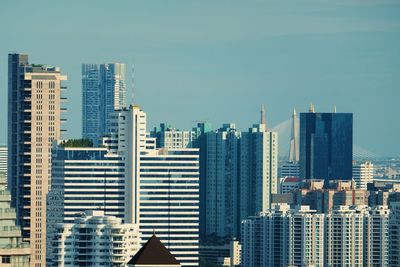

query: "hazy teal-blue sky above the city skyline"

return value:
[0, 0, 400, 156]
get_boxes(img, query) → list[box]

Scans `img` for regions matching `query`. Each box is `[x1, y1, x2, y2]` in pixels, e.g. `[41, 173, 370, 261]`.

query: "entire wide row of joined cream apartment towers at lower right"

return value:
[242, 204, 389, 267]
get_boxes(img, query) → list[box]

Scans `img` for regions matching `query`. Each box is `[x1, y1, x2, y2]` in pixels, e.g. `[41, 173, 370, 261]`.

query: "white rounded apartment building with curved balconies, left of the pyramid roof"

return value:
[48, 210, 140, 267]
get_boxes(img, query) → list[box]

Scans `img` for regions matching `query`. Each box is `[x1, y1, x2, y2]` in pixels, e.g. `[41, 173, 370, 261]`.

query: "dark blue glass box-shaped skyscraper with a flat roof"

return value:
[300, 106, 353, 181]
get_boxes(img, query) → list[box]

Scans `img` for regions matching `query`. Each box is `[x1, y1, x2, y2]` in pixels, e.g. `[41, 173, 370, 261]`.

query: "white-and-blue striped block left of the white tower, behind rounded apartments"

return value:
[46, 146, 126, 262]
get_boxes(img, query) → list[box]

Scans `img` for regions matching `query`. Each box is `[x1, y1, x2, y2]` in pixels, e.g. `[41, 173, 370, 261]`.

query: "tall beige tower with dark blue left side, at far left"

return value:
[8, 54, 67, 267]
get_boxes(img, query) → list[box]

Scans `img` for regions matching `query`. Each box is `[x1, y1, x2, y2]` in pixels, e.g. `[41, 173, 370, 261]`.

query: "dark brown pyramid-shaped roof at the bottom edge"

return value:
[128, 234, 179, 265]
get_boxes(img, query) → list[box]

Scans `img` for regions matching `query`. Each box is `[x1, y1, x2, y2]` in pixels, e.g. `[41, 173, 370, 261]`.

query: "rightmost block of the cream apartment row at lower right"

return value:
[325, 206, 389, 267]
